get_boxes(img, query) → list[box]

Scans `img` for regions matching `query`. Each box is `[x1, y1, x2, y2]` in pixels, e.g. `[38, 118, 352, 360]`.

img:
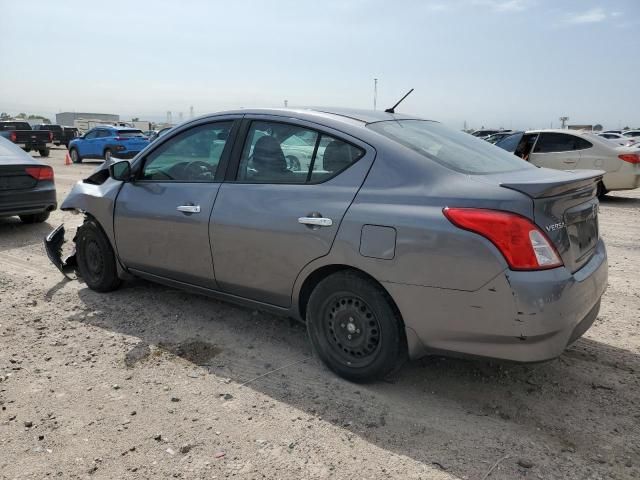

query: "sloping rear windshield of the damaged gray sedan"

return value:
[367, 120, 536, 174]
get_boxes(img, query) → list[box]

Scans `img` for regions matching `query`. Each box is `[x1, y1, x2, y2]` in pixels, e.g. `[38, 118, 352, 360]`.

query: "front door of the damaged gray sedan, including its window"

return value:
[114, 120, 233, 288]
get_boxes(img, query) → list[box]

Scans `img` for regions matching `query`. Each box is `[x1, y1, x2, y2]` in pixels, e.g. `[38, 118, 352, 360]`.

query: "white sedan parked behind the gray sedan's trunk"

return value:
[496, 130, 640, 196]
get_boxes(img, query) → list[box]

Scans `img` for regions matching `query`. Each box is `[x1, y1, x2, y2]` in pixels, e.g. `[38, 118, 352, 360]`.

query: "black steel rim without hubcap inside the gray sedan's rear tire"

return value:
[323, 294, 380, 367]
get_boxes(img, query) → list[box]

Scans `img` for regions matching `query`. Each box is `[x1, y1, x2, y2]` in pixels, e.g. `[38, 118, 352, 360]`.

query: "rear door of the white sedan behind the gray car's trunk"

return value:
[529, 132, 581, 170]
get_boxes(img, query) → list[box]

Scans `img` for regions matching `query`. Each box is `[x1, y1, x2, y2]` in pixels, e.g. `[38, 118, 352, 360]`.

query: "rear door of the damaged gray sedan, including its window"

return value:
[210, 117, 375, 307]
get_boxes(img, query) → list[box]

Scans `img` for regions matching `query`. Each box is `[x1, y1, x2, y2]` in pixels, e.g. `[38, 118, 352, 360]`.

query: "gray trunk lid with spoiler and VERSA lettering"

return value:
[476, 168, 605, 273]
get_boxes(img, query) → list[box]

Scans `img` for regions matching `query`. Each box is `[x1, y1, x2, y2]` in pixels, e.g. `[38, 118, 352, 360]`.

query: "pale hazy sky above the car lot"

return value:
[0, 0, 640, 128]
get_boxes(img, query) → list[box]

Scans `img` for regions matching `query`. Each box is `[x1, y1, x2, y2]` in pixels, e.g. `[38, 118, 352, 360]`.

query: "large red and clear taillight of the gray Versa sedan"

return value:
[443, 208, 562, 270]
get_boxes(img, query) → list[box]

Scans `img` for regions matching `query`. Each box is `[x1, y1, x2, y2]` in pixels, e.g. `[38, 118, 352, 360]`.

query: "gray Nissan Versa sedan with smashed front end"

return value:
[46, 109, 607, 381]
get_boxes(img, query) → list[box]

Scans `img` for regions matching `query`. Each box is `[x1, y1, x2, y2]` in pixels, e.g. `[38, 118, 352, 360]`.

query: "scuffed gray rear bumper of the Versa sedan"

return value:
[385, 240, 608, 362]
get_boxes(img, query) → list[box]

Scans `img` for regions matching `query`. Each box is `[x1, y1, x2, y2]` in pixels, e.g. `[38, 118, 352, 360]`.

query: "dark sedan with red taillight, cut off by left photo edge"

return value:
[0, 137, 57, 223]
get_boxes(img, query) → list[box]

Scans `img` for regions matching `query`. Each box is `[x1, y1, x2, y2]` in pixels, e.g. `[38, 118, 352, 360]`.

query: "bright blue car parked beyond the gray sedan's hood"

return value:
[69, 126, 149, 163]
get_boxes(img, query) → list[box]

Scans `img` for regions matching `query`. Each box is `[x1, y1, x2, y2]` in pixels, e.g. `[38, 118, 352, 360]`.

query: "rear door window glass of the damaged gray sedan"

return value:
[237, 121, 364, 184]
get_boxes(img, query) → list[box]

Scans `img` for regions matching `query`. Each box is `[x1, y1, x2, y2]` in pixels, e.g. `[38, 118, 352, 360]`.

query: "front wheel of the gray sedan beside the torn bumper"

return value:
[76, 219, 121, 292]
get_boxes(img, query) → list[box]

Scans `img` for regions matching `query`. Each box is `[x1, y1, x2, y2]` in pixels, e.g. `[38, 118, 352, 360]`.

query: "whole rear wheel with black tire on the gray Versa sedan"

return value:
[306, 271, 407, 382]
